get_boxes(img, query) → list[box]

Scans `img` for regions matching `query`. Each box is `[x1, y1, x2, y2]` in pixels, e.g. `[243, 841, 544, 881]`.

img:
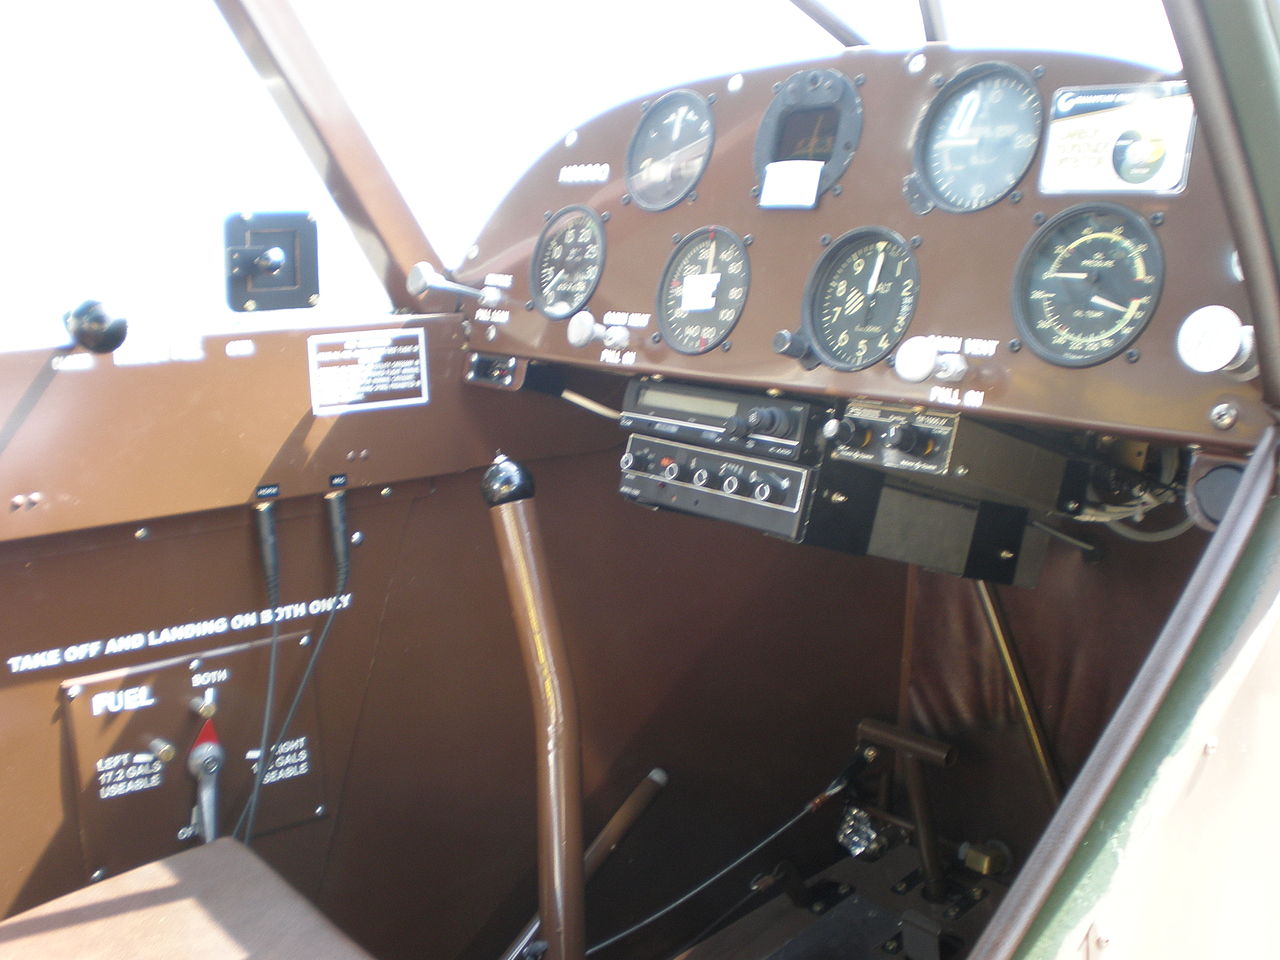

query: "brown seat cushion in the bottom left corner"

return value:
[0, 838, 370, 960]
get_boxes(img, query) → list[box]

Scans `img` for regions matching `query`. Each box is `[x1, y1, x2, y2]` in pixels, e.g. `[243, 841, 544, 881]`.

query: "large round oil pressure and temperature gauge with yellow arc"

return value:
[1014, 204, 1165, 366]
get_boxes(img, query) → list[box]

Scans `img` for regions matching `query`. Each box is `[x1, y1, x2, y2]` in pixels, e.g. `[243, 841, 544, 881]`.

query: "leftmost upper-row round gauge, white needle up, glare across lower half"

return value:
[626, 90, 716, 210]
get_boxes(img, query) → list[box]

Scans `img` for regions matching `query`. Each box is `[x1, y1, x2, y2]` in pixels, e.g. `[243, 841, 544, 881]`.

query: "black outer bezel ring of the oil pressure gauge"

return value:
[1011, 201, 1165, 367]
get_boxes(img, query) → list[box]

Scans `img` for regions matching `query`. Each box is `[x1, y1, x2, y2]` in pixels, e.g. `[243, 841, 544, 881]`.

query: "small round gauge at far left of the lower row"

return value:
[530, 206, 604, 320]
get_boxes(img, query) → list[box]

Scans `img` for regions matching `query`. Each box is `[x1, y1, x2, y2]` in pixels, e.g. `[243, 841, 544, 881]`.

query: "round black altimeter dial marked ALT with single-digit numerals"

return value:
[804, 227, 920, 370]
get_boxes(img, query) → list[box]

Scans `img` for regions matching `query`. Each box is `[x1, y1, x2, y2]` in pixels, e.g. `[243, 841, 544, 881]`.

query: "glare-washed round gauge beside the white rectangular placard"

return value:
[915, 63, 1043, 212]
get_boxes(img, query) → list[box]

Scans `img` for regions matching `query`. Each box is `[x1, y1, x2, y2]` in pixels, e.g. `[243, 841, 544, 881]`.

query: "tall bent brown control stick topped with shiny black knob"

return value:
[481, 453, 586, 960]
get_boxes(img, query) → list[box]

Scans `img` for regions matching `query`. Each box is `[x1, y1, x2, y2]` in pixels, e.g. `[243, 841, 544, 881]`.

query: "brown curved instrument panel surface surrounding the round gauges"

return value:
[457, 45, 1267, 448]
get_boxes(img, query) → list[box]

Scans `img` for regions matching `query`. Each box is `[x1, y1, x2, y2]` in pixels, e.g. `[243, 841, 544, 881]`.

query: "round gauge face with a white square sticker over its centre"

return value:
[658, 227, 751, 353]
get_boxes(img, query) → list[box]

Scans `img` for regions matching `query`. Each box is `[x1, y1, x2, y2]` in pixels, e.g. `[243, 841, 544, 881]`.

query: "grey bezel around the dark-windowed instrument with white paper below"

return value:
[751, 69, 863, 204]
